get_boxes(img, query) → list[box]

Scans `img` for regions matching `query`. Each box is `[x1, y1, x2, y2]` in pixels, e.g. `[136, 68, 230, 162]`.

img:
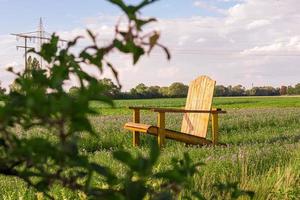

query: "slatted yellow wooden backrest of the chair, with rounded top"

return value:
[181, 76, 216, 137]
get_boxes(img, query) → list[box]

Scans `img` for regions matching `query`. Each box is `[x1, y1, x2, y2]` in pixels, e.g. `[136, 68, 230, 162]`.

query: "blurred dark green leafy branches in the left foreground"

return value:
[0, 0, 199, 199]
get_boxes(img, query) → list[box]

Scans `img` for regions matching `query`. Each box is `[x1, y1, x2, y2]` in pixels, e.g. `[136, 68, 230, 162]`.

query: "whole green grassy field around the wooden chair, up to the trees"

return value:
[0, 97, 300, 200]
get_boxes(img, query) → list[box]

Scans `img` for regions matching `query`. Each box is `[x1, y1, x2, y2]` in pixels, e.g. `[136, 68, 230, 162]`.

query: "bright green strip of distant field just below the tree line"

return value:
[91, 96, 300, 115]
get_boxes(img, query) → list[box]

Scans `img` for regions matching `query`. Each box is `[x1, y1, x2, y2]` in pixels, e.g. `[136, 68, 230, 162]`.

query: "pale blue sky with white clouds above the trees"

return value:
[0, 0, 300, 90]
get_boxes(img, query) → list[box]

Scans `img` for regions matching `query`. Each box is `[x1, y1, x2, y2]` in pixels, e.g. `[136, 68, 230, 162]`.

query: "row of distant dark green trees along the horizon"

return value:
[69, 78, 300, 99]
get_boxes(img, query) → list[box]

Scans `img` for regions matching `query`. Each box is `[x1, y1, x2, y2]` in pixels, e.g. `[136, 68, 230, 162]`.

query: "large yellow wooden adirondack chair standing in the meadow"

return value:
[124, 76, 226, 146]
